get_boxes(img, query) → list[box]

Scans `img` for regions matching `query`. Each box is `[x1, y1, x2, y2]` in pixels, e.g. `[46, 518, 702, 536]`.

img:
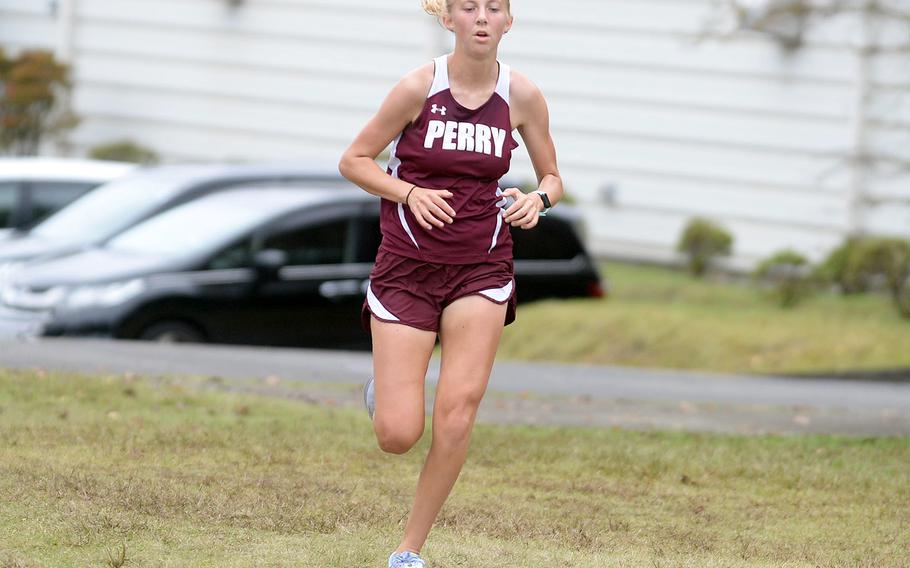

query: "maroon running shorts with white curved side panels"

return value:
[360, 250, 515, 333]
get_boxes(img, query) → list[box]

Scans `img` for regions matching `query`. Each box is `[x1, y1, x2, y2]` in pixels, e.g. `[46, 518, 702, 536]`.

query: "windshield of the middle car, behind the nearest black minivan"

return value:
[31, 179, 180, 243]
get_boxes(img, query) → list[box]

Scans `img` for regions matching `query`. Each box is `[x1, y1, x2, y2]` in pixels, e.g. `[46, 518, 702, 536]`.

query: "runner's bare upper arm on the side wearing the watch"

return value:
[510, 71, 559, 182]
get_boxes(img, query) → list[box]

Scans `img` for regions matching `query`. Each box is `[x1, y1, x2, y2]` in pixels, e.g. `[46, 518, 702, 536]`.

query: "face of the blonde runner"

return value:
[444, 0, 512, 51]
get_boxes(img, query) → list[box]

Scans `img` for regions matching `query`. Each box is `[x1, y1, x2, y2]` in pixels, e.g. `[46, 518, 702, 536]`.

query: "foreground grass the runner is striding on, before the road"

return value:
[0, 370, 910, 568]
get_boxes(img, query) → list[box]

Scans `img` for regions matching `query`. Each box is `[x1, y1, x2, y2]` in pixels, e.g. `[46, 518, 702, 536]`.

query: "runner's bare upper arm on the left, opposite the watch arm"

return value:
[345, 63, 433, 159]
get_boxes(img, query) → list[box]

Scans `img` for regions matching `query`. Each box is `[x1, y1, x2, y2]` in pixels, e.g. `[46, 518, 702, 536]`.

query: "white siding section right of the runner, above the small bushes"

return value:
[502, 0, 868, 266]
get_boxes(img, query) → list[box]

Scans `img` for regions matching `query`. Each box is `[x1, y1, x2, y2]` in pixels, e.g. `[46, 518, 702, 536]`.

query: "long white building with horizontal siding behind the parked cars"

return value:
[0, 0, 910, 267]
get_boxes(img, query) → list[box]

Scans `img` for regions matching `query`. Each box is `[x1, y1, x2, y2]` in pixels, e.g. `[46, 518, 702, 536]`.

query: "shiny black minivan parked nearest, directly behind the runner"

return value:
[0, 186, 603, 348]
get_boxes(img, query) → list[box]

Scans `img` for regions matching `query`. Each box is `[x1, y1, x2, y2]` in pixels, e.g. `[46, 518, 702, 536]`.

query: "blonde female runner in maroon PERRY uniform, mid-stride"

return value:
[339, 0, 563, 568]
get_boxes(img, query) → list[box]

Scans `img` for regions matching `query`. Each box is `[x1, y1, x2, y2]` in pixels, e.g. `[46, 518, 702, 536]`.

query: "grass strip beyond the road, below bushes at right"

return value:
[499, 262, 910, 373]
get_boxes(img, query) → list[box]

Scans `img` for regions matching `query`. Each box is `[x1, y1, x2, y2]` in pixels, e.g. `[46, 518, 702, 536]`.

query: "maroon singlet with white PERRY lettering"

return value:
[379, 55, 518, 264]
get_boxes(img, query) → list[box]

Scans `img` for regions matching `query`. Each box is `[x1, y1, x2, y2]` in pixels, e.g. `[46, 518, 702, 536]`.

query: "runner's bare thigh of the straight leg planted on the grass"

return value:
[434, 295, 507, 415]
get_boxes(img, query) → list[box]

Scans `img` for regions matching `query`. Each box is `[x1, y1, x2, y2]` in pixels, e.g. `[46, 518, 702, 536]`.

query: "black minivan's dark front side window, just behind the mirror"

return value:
[262, 219, 350, 266]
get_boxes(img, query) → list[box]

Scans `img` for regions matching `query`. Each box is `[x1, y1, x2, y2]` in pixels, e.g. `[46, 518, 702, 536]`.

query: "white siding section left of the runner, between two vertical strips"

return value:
[64, 0, 431, 160]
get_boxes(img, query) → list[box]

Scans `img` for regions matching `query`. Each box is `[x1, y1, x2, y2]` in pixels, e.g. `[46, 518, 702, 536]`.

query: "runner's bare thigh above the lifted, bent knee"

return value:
[371, 317, 436, 428]
